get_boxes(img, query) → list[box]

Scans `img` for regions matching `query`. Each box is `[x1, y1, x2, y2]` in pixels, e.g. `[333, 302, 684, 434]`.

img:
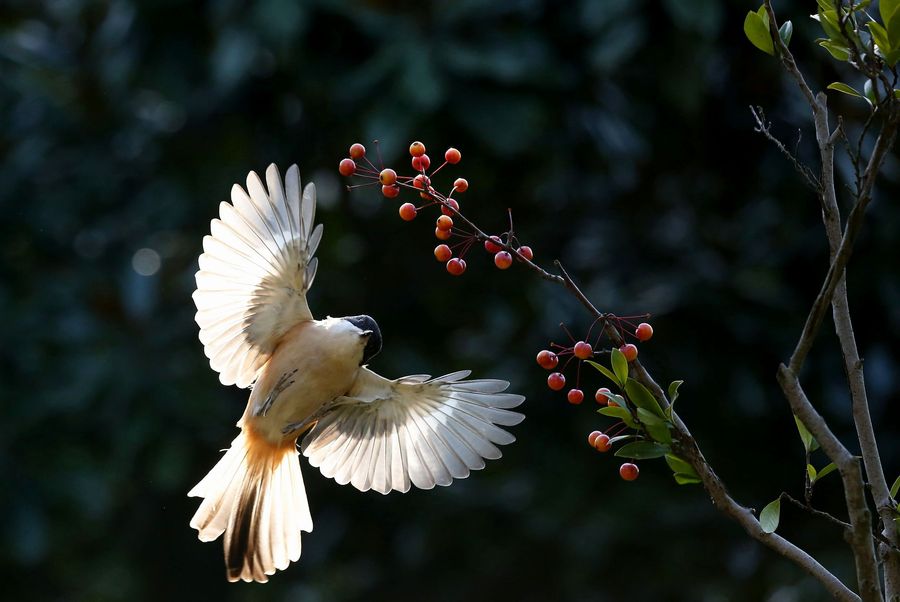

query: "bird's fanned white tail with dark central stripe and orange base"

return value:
[188, 429, 312, 583]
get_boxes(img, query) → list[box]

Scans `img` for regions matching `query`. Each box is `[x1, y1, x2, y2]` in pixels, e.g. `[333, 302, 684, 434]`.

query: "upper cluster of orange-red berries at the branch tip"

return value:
[338, 140, 534, 276]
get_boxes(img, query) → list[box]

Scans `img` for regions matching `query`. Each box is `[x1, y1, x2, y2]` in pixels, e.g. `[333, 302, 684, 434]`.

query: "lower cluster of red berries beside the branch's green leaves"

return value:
[536, 315, 653, 481]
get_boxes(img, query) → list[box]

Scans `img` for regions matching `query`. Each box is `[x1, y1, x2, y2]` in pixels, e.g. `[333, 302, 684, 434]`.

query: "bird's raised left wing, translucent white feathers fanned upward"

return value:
[194, 164, 322, 387]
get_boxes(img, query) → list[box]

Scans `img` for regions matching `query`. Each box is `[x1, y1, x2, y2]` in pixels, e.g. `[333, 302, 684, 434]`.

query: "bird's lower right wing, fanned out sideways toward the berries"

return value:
[302, 368, 525, 493]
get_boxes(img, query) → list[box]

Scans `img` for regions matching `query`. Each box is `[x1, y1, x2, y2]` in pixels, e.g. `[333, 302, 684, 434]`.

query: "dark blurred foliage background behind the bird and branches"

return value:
[0, 0, 900, 602]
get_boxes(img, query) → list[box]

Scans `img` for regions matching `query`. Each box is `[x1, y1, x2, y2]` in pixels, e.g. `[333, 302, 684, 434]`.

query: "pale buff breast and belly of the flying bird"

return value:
[238, 321, 365, 443]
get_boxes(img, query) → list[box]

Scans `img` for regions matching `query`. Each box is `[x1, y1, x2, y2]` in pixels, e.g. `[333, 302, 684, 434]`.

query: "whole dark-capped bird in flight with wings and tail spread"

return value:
[188, 164, 525, 583]
